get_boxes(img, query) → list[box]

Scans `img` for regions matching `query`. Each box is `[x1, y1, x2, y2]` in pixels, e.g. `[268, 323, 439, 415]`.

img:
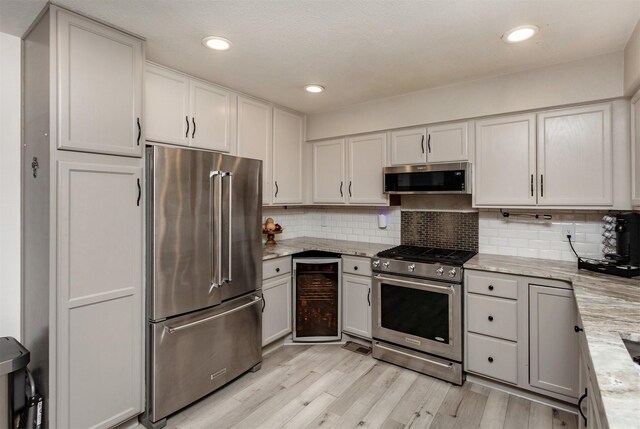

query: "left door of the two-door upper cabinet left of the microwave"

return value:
[313, 139, 347, 203]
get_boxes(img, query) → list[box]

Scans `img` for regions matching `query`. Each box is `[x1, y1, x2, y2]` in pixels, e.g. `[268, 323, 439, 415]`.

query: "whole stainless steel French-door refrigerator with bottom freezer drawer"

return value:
[143, 146, 262, 428]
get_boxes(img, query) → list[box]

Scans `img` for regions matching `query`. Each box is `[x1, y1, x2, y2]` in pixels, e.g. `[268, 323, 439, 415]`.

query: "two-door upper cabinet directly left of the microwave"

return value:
[313, 133, 389, 205]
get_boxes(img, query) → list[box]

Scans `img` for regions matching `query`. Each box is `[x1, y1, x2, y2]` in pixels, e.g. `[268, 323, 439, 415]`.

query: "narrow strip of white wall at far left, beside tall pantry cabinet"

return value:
[0, 33, 20, 339]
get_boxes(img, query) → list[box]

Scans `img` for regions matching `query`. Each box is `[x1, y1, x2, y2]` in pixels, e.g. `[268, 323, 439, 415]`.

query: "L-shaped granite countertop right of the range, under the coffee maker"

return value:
[464, 254, 640, 428]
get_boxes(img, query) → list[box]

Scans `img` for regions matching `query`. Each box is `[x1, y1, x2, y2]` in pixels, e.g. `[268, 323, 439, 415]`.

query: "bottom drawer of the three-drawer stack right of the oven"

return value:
[467, 333, 518, 384]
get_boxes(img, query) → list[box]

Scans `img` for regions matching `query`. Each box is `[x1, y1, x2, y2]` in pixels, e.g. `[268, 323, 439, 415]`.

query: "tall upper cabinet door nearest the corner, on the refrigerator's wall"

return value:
[273, 108, 304, 204]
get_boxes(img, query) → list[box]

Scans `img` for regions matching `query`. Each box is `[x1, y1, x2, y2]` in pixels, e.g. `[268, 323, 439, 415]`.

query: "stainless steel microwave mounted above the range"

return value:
[384, 162, 471, 194]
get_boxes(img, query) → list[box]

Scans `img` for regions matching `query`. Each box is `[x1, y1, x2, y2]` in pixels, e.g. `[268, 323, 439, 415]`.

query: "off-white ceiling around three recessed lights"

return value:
[0, 0, 640, 113]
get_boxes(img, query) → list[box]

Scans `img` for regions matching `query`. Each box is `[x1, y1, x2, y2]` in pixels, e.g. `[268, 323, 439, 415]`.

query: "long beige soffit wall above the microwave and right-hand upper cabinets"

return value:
[307, 52, 624, 140]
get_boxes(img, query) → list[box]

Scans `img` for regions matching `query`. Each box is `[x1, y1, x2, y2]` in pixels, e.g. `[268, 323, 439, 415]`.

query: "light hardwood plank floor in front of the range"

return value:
[167, 345, 577, 429]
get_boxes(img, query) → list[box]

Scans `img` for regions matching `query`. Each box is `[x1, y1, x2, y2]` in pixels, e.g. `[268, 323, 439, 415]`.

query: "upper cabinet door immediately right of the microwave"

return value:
[473, 115, 536, 206]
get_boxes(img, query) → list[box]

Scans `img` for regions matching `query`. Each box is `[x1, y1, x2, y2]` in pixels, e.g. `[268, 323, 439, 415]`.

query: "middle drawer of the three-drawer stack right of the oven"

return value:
[467, 293, 518, 341]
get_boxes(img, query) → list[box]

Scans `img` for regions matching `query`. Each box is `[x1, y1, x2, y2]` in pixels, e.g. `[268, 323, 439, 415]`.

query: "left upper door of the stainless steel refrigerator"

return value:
[147, 146, 222, 320]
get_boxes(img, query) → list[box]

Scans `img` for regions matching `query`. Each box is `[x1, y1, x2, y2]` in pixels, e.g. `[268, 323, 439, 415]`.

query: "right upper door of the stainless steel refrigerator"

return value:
[214, 154, 262, 301]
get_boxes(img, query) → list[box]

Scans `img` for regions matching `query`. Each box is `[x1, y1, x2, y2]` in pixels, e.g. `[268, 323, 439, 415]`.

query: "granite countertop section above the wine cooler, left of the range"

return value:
[262, 237, 393, 261]
